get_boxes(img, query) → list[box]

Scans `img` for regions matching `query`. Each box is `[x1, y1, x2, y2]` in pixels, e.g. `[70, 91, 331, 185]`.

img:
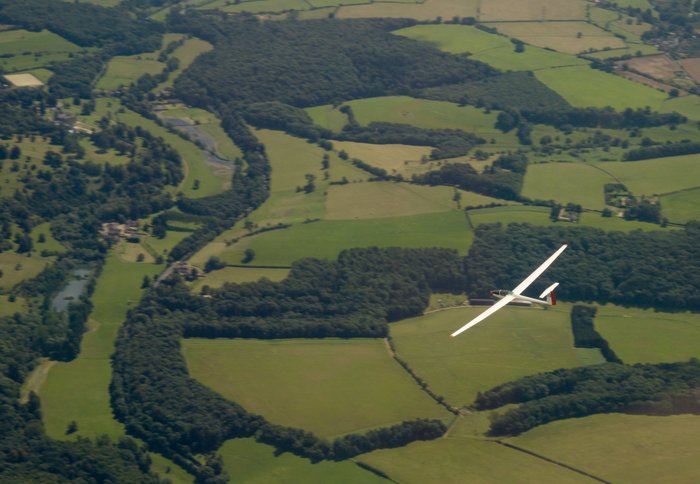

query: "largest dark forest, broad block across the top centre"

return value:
[171, 14, 494, 107]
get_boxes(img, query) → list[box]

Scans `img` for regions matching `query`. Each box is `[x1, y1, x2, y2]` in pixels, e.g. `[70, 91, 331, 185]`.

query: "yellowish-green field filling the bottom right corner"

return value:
[508, 414, 700, 482]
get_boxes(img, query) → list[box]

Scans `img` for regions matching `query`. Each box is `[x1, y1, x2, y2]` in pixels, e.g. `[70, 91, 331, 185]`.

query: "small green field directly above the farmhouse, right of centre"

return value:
[522, 163, 615, 209]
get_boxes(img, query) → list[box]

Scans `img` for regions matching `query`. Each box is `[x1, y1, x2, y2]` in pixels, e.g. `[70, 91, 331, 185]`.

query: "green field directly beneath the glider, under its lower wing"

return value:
[391, 304, 603, 406]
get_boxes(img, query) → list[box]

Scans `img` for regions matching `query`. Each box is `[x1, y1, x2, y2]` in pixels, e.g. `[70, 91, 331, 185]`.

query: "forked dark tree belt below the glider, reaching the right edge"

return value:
[474, 359, 700, 435]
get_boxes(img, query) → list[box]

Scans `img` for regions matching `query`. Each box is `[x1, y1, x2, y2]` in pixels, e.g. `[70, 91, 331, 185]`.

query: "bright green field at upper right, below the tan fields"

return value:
[535, 66, 667, 110]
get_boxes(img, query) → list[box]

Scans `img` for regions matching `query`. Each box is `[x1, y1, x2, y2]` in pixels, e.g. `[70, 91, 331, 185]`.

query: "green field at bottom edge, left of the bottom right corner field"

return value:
[357, 430, 591, 484]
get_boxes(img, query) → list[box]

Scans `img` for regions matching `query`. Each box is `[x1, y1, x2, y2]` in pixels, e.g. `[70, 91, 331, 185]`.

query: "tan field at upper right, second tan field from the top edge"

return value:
[490, 22, 625, 54]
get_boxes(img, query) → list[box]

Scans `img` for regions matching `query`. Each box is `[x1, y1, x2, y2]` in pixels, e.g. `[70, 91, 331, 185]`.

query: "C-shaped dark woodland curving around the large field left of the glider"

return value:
[111, 248, 464, 470]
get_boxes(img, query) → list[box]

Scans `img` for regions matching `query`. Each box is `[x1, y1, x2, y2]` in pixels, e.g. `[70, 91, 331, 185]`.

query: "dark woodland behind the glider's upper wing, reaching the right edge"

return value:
[466, 222, 700, 310]
